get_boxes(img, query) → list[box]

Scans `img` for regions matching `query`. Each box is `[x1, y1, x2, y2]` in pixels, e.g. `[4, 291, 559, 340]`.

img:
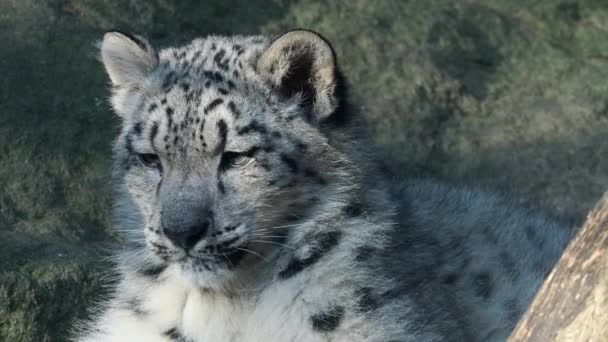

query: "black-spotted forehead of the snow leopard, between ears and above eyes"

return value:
[127, 37, 302, 166]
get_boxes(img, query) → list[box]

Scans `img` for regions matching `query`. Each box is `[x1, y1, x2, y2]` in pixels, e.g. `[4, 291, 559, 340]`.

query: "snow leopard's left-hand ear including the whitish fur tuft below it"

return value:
[100, 31, 158, 118]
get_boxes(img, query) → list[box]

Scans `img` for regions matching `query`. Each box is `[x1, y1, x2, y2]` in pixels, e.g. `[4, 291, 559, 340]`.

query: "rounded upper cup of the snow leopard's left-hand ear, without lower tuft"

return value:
[101, 31, 158, 87]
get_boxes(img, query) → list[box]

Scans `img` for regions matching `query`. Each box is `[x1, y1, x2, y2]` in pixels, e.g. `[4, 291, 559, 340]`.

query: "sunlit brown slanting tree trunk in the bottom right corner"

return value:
[509, 193, 608, 342]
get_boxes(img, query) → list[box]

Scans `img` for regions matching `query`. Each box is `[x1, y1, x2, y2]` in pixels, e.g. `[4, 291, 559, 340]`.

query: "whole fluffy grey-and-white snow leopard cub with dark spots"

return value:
[77, 30, 572, 342]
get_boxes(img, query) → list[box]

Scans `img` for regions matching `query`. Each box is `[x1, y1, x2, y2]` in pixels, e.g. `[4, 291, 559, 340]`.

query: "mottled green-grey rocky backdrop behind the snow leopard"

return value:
[0, 0, 608, 341]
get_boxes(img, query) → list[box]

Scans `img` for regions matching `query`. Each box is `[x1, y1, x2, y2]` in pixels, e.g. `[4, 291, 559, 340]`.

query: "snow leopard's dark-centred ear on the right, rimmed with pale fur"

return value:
[257, 30, 339, 122]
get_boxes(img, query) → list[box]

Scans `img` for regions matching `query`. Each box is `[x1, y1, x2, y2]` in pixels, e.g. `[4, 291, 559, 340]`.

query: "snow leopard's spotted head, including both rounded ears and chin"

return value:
[101, 31, 350, 288]
